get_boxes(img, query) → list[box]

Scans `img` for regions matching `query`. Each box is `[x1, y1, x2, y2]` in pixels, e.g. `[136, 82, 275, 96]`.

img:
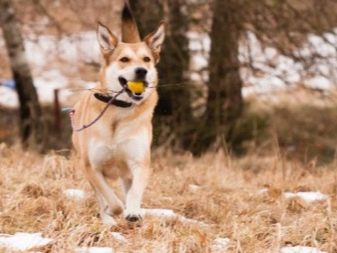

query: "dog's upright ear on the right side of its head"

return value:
[144, 21, 165, 63]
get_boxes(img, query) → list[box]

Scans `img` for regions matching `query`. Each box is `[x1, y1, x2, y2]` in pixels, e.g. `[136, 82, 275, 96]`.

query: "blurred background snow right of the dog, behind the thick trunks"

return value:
[188, 30, 337, 97]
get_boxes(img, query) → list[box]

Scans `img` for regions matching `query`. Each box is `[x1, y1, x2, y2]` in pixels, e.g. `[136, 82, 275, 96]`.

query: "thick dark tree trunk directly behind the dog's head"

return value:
[130, 0, 192, 147]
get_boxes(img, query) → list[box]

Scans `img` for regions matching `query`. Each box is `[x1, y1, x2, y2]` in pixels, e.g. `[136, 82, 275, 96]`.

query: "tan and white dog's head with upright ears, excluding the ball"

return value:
[97, 18, 165, 104]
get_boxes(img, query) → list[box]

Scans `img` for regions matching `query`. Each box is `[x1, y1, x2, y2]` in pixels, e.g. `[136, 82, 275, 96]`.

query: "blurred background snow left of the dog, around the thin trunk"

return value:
[0, 31, 100, 108]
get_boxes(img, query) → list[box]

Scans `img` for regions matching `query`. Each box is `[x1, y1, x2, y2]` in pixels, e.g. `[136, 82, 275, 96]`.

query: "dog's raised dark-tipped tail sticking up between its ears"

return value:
[122, 0, 141, 43]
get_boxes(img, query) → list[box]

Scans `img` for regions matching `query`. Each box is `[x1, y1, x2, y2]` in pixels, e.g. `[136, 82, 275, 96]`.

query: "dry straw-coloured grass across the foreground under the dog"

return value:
[0, 141, 337, 252]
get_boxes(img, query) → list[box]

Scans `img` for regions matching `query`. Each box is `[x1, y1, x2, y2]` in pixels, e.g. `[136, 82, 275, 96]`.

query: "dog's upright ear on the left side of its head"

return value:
[96, 22, 118, 54]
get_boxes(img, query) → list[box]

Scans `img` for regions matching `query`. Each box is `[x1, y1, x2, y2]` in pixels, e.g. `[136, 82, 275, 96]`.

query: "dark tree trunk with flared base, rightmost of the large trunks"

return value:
[192, 0, 243, 153]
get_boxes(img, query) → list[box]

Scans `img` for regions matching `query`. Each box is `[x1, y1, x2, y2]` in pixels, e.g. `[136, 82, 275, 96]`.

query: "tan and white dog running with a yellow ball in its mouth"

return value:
[72, 4, 165, 224]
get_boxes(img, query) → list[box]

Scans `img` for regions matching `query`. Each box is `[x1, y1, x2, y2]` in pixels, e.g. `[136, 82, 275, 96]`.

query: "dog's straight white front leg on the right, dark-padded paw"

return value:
[124, 161, 151, 222]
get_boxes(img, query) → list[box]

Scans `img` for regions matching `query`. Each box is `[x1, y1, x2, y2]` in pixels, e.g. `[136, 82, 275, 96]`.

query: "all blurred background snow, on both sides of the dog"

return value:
[0, 29, 337, 107]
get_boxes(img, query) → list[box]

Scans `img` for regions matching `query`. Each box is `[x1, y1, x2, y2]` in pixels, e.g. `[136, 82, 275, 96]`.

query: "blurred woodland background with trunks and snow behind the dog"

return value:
[0, 0, 337, 163]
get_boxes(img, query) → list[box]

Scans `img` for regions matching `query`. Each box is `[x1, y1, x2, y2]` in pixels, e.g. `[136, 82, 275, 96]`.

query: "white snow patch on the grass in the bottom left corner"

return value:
[0, 232, 53, 251]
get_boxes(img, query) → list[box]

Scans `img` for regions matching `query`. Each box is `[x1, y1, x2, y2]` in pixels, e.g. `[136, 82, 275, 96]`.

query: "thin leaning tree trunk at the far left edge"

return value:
[0, 0, 42, 147]
